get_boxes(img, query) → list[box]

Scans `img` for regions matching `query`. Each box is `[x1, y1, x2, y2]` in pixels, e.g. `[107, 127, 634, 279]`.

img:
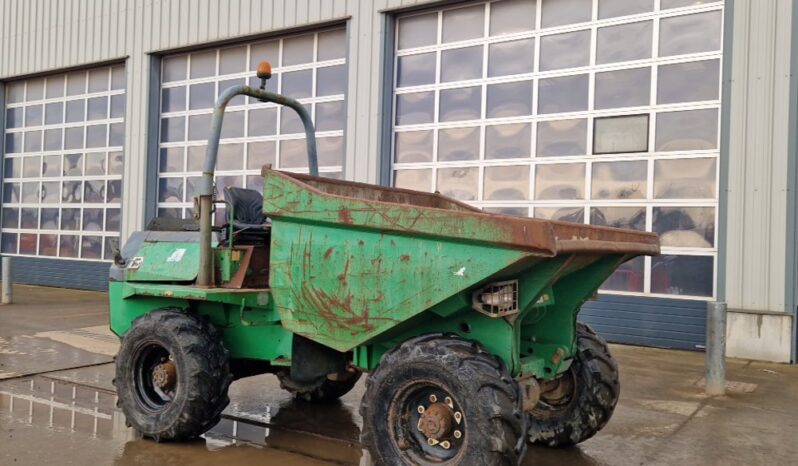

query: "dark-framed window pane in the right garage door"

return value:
[593, 115, 648, 154]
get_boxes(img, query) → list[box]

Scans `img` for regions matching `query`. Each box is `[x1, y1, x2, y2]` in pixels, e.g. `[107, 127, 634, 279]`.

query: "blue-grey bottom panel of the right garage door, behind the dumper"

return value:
[579, 295, 706, 350]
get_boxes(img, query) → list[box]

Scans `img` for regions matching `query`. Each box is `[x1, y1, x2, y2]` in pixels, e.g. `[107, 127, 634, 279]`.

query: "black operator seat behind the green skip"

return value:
[224, 186, 271, 243]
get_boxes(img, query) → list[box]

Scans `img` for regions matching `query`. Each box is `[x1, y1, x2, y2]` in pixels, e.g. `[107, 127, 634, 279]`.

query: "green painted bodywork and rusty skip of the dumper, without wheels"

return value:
[109, 170, 658, 379]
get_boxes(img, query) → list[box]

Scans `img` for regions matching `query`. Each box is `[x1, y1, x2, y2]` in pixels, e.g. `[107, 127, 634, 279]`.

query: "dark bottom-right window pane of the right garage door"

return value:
[651, 256, 715, 296]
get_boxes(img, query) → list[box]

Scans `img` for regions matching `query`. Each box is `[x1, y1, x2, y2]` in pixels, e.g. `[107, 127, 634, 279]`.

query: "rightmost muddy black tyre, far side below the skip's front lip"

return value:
[529, 324, 621, 447]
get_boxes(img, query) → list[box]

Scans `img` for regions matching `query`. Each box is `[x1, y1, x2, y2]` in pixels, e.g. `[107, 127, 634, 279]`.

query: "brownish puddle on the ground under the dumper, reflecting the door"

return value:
[0, 375, 370, 466]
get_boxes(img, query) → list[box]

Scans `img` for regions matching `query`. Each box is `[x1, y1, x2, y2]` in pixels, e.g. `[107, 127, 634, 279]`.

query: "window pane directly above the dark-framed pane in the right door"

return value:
[595, 68, 651, 110]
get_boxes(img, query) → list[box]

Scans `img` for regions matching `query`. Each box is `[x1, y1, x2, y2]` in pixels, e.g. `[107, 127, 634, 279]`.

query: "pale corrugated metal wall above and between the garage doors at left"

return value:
[0, 0, 438, 246]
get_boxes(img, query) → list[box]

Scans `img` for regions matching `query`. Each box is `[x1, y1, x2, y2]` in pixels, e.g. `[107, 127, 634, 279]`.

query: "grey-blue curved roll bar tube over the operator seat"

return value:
[194, 84, 319, 287]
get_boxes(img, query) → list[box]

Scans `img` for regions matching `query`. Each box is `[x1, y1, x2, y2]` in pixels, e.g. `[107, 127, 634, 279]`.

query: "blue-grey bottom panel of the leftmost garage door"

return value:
[1, 257, 111, 291]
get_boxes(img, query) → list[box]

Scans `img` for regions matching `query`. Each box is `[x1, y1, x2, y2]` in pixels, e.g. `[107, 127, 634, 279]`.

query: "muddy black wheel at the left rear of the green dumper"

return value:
[114, 309, 233, 441]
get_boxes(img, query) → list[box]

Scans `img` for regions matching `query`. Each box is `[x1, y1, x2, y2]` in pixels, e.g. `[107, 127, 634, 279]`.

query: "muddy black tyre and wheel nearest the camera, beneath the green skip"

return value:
[360, 334, 527, 466]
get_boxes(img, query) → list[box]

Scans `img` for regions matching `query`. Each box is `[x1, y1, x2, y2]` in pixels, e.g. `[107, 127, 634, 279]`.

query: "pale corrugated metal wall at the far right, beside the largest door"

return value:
[720, 0, 796, 311]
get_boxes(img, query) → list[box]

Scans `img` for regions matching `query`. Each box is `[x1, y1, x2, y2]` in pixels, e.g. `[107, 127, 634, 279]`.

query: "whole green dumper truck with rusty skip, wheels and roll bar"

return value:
[110, 63, 659, 465]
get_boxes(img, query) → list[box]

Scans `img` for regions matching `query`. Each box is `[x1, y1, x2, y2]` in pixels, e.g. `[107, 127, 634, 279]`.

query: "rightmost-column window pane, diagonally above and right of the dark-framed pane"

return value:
[657, 60, 720, 104]
